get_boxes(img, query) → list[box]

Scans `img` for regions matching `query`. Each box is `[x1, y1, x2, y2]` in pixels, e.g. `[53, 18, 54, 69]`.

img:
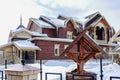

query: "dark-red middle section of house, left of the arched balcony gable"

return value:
[27, 16, 82, 59]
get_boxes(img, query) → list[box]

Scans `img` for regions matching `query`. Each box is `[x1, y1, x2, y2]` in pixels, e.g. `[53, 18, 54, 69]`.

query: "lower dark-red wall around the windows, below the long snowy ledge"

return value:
[34, 40, 76, 60]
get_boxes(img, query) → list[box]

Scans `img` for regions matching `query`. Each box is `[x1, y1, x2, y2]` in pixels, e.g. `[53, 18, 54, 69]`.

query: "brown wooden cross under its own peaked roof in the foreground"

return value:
[61, 29, 105, 74]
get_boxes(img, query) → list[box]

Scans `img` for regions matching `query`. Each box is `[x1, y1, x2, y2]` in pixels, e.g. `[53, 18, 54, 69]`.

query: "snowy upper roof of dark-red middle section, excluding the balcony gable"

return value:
[27, 15, 80, 29]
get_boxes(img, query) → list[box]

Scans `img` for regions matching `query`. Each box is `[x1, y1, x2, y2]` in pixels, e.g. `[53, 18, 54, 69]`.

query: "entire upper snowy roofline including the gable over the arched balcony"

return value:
[27, 12, 111, 33]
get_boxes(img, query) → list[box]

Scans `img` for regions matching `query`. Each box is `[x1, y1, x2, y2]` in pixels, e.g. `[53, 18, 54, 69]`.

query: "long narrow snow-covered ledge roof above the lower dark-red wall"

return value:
[30, 37, 73, 42]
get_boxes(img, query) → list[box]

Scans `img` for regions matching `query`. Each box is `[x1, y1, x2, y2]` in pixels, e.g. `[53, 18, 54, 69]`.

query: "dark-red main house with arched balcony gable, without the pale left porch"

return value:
[27, 12, 118, 59]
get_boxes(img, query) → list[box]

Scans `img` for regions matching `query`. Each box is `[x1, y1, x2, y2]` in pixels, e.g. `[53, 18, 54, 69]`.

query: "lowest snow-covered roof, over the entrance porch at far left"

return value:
[0, 40, 41, 50]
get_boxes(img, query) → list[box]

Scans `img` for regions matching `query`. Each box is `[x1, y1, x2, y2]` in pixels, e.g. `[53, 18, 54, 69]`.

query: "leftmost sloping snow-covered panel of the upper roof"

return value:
[30, 18, 54, 29]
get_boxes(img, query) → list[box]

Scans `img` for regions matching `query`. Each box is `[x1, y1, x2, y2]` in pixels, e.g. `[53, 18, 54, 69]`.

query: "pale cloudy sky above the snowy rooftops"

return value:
[0, 0, 120, 45]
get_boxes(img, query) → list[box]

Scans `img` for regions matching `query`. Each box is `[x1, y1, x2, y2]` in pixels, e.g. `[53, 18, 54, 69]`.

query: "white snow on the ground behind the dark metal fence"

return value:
[0, 60, 120, 80]
